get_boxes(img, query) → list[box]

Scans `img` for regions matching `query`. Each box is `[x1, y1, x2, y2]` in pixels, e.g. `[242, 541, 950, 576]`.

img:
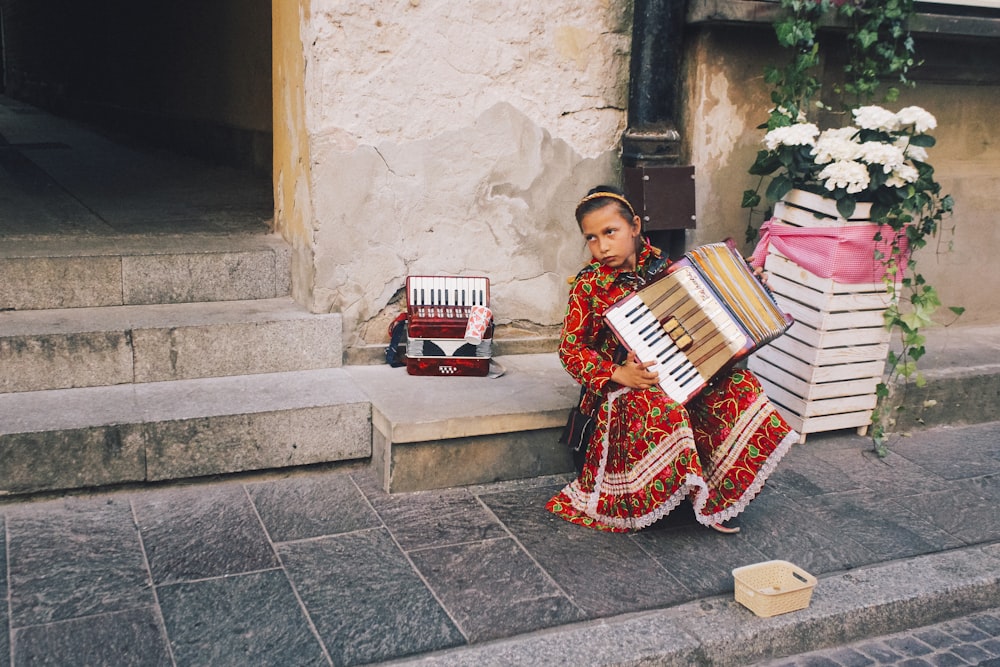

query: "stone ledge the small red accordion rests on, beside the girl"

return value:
[345, 353, 580, 493]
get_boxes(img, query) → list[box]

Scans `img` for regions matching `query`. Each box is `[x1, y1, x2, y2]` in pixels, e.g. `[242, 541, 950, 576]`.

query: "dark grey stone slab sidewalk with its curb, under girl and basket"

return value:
[0, 422, 1000, 665]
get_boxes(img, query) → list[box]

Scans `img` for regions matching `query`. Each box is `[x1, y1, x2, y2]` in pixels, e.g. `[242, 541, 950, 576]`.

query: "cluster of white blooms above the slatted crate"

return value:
[764, 106, 937, 194]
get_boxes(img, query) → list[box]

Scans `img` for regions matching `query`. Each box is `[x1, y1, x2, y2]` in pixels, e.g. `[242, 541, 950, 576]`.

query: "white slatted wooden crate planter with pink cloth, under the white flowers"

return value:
[748, 193, 889, 442]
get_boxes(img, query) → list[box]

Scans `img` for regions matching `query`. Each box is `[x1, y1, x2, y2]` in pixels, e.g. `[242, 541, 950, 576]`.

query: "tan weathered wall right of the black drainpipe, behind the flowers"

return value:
[683, 26, 1000, 324]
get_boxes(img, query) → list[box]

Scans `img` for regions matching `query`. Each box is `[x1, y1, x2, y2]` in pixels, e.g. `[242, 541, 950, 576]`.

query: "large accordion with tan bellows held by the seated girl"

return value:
[604, 240, 792, 404]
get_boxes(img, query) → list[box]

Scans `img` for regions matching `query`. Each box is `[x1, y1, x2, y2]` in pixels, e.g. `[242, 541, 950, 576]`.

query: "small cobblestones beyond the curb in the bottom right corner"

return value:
[756, 607, 1000, 667]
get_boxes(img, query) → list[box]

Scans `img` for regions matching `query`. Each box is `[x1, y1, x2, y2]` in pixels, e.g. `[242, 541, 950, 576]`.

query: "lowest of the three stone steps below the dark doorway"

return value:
[0, 368, 372, 495]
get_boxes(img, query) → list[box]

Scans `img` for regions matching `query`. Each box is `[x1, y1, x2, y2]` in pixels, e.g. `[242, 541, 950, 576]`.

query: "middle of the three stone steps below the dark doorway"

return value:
[0, 297, 343, 393]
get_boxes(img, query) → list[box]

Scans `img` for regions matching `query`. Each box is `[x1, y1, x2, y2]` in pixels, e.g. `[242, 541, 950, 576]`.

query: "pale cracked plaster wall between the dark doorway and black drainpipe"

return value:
[292, 0, 630, 354]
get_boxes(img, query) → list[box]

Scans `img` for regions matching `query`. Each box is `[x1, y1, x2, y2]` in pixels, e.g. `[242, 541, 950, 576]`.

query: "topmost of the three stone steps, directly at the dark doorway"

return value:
[0, 234, 291, 310]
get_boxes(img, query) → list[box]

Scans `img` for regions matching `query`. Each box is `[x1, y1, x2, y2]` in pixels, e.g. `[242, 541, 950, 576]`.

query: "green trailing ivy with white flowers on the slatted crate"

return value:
[742, 0, 963, 456]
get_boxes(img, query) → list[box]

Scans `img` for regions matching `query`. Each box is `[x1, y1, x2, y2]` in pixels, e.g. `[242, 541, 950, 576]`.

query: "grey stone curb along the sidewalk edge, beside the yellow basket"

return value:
[385, 543, 1000, 667]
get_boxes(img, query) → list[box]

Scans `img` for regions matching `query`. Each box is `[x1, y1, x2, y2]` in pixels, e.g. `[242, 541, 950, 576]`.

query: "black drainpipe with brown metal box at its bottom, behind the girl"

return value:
[622, 0, 695, 257]
